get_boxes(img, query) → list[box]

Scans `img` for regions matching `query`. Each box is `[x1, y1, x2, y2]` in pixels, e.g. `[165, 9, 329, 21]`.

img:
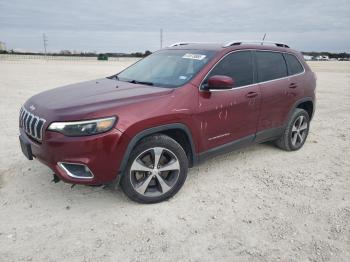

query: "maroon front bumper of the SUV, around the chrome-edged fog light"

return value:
[20, 128, 127, 185]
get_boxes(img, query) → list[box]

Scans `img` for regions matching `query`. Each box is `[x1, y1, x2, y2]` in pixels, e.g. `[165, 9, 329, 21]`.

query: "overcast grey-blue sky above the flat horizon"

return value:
[0, 0, 350, 52]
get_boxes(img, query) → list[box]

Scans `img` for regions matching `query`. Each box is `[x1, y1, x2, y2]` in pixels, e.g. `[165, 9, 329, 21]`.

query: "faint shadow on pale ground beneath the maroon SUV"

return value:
[8, 143, 279, 208]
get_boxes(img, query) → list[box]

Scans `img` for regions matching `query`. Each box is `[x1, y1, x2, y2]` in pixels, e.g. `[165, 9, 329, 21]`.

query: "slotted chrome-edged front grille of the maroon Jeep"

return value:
[19, 107, 46, 141]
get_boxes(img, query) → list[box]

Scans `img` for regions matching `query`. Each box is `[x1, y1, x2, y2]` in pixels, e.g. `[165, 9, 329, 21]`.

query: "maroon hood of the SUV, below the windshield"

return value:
[25, 78, 172, 120]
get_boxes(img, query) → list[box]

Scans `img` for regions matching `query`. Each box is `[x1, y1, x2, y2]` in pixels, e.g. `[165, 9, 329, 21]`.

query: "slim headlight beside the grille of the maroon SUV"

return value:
[48, 117, 116, 136]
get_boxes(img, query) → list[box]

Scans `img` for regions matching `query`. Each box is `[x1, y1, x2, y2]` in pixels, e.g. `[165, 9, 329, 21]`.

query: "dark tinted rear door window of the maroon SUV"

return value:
[256, 51, 287, 82]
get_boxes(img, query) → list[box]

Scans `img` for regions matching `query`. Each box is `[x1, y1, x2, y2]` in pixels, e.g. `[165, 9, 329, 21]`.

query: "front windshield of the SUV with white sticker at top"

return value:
[117, 49, 214, 87]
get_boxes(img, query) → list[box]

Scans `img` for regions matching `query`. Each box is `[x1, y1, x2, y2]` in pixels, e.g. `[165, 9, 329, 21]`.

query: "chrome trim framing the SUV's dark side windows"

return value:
[198, 49, 306, 92]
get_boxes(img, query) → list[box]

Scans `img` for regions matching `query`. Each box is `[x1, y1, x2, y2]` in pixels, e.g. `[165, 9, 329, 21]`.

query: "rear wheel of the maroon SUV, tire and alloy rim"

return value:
[275, 108, 310, 151]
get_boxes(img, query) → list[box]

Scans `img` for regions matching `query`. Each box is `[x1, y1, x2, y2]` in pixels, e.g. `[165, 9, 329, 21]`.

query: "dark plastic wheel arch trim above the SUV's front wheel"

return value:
[118, 123, 197, 181]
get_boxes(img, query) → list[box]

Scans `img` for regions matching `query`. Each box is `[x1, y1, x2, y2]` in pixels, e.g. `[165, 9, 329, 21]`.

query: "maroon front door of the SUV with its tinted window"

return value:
[197, 51, 261, 151]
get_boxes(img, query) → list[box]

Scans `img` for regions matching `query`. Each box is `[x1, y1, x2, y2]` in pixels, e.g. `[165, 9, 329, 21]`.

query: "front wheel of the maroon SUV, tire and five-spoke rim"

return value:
[121, 134, 188, 204]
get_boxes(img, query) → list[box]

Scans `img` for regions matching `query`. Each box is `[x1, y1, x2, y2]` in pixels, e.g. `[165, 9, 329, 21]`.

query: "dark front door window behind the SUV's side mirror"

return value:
[204, 51, 253, 87]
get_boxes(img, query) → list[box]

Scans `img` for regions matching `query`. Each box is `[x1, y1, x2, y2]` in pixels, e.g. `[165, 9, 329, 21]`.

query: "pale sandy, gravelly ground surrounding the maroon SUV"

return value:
[0, 60, 350, 262]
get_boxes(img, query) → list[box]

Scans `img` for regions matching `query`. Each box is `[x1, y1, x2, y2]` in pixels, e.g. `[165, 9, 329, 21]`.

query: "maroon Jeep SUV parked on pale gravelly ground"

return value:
[19, 42, 316, 203]
